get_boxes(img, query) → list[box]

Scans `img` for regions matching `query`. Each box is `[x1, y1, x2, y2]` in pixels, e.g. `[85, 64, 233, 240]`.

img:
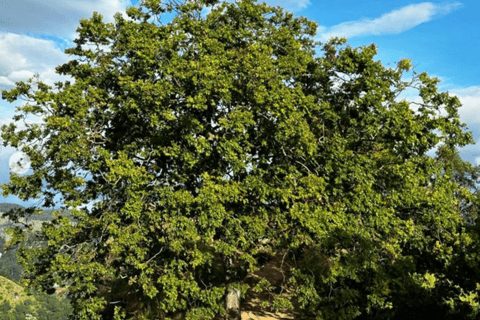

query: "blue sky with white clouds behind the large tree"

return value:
[0, 0, 480, 205]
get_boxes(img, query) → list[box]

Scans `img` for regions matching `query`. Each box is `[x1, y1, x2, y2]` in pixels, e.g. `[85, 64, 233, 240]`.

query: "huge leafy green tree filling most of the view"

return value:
[2, 0, 480, 319]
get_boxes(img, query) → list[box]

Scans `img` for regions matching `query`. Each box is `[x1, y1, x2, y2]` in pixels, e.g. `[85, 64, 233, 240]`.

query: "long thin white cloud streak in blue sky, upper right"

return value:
[317, 2, 462, 41]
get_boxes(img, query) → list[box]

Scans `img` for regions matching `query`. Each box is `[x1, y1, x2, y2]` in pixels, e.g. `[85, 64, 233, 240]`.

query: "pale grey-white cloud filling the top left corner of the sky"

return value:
[0, 0, 131, 38]
